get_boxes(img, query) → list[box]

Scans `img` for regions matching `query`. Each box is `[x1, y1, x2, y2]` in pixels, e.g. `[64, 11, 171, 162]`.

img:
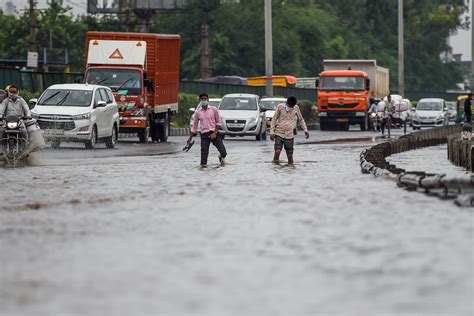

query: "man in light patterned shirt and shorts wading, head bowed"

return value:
[270, 97, 309, 165]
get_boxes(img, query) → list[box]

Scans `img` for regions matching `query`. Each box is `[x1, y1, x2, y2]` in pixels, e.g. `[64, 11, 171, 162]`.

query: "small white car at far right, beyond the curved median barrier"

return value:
[413, 98, 448, 129]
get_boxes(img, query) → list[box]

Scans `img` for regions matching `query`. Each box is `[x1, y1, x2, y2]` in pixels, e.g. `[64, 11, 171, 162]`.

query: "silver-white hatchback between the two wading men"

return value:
[219, 93, 267, 140]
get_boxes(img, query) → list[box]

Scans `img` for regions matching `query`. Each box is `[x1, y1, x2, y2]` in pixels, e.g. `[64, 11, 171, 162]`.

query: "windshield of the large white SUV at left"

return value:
[38, 89, 92, 107]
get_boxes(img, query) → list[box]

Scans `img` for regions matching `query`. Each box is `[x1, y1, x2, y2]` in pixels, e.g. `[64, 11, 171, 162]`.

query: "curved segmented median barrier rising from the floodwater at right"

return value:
[360, 125, 474, 206]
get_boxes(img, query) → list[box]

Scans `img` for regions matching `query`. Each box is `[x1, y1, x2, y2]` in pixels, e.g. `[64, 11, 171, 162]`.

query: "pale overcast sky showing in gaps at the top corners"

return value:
[0, 0, 474, 60]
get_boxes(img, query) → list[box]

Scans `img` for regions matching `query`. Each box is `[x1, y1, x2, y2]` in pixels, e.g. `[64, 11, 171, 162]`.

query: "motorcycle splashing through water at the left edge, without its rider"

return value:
[1, 115, 29, 166]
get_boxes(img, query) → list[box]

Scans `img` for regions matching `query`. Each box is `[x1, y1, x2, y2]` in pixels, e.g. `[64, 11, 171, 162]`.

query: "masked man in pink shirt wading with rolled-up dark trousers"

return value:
[188, 93, 227, 168]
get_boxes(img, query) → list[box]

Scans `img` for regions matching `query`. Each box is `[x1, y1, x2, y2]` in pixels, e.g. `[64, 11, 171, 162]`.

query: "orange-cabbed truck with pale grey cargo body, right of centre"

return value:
[316, 59, 389, 131]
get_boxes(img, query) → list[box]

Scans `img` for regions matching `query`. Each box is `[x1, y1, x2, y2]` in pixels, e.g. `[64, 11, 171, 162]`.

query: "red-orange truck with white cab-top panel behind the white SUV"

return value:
[84, 32, 180, 143]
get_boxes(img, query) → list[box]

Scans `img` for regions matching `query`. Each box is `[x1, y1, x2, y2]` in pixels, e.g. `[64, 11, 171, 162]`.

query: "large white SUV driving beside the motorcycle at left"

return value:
[30, 84, 120, 149]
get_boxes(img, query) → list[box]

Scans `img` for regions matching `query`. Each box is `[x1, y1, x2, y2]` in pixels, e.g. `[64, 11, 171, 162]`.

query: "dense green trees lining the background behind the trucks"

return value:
[0, 0, 468, 91]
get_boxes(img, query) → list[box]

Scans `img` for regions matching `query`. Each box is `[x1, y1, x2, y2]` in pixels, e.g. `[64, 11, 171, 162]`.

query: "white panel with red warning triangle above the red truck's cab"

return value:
[87, 40, 146, 66]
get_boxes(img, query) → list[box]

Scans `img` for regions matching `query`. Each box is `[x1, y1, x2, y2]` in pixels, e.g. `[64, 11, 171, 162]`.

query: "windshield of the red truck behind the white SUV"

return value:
[86, 68, 142, 95]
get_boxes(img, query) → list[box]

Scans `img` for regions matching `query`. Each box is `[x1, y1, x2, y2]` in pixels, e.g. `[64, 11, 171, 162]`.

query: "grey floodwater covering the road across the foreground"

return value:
[0, 131, 474, 315]
